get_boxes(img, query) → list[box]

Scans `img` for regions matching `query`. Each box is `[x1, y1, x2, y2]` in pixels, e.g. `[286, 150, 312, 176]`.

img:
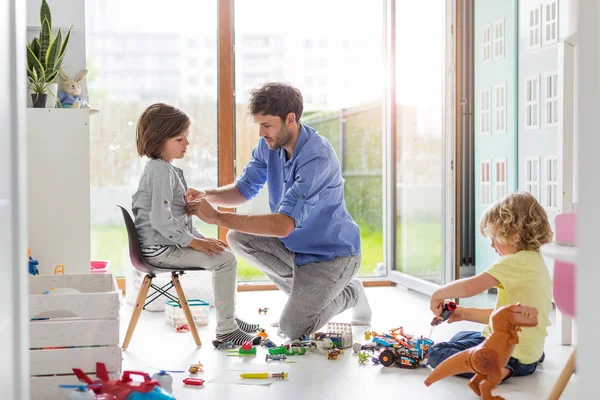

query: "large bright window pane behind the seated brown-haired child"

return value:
[86, 0, 217, 276]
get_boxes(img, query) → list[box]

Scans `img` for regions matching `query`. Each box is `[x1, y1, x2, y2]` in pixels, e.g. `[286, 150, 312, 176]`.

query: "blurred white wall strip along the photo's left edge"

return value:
[0, 0, 29, 400]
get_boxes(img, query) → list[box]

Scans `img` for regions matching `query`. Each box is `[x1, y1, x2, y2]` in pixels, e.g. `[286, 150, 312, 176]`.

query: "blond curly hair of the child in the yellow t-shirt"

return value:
[479, 192, 554, 251]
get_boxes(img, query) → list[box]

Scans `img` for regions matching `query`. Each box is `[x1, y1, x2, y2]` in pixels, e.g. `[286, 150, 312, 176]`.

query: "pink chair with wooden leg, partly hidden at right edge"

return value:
[548, 214, 576, 400]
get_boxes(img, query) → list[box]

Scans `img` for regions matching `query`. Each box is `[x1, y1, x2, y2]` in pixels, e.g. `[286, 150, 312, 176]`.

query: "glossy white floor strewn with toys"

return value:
[121, 287, 577, 400]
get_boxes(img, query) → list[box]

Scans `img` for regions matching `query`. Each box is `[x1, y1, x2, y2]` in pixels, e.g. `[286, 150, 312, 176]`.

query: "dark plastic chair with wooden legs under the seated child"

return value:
[117, 204, 202, 350]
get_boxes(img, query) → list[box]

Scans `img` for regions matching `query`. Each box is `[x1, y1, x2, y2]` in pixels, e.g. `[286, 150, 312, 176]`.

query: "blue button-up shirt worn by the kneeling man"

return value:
[235, 125, 360, 265]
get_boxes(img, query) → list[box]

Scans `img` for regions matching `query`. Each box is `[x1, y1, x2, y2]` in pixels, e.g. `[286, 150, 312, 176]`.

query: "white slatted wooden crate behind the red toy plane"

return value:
[29, 274, 122, 399]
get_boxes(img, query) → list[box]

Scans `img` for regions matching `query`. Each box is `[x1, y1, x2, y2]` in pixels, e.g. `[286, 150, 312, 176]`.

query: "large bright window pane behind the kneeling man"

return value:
[235, 0, 383, 279]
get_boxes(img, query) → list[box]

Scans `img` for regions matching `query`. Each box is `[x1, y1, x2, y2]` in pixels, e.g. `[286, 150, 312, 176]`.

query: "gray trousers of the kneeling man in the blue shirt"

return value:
[227, 231, 361, 339]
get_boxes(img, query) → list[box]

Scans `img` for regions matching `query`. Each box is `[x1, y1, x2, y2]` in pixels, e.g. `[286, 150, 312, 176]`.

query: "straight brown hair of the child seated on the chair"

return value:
[135, 103, 191, 158]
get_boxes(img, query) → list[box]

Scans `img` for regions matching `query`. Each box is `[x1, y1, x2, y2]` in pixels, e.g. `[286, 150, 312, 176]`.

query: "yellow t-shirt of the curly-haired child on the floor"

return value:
[481, 251, 552, 364]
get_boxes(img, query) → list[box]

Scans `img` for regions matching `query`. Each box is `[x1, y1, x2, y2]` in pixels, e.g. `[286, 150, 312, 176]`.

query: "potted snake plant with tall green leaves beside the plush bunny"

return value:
[27, 0, 73, 107]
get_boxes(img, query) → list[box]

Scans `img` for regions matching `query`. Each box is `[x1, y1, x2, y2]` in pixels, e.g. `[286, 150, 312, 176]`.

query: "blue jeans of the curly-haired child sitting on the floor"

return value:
[428, 331, 545, 380]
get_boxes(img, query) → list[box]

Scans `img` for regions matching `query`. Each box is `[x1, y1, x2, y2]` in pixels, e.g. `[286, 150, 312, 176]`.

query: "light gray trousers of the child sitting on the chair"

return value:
[146, 246, 238, 334]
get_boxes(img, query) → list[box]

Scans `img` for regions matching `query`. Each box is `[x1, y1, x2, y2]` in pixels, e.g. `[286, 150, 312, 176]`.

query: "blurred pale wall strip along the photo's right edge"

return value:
[576, 0, 600, 399]
